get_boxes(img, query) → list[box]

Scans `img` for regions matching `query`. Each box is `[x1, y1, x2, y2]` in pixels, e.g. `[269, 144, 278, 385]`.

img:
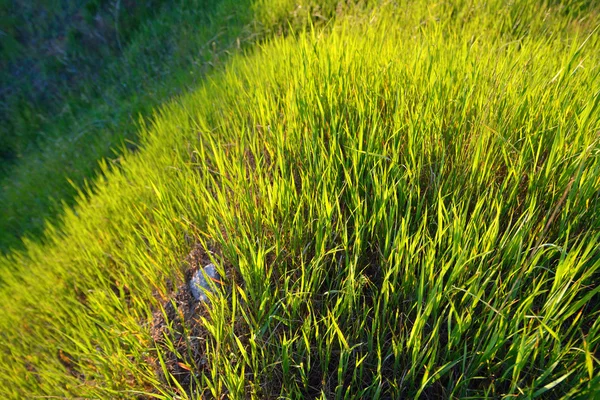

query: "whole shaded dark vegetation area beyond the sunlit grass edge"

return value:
[0, 0, 227, 250]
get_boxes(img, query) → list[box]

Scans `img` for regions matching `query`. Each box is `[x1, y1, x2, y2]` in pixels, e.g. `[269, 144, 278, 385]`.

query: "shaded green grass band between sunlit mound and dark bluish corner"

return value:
[0, 1, 220, 251]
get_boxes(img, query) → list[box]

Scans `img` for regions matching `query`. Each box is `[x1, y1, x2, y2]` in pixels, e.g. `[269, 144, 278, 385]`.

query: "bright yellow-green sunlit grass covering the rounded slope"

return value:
[0, 1, 600, 398]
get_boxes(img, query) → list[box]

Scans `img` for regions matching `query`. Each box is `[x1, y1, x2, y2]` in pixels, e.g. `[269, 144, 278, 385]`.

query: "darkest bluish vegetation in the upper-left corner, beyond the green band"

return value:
[0, 0, 166, 126]
